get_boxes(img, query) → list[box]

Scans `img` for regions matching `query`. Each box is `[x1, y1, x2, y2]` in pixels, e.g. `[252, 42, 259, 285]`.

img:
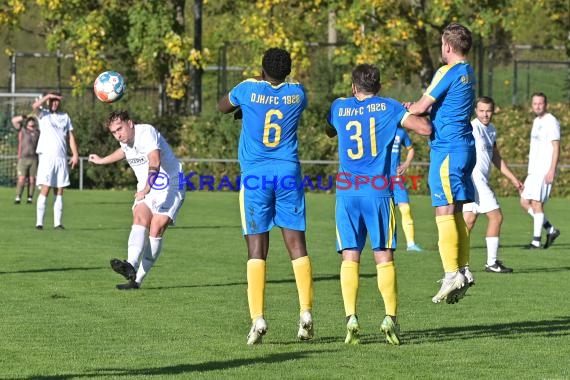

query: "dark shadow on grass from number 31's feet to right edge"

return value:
[402, 317, 570, 344]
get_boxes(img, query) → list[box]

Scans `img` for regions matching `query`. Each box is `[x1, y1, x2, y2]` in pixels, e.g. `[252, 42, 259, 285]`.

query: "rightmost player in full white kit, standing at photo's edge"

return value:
[521, 92, 560, 249]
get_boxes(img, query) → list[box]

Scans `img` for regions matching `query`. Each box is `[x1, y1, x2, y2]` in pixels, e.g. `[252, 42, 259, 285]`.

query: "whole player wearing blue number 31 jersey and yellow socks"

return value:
[326, 64, 431, 345]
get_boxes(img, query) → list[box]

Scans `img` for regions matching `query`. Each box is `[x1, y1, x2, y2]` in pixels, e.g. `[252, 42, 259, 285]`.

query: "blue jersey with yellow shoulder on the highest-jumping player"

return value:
[424, 62, 475, 152]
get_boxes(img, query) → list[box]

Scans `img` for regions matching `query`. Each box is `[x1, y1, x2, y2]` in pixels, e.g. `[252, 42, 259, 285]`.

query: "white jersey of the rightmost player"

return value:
[528, 113, 560, 176]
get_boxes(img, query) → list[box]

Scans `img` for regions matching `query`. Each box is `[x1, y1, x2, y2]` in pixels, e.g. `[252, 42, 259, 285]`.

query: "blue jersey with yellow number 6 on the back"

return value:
[229, 79, 307, 171]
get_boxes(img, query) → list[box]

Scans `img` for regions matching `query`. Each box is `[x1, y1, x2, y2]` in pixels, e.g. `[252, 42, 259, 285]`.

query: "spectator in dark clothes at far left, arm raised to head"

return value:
[12, 115, 40, 204]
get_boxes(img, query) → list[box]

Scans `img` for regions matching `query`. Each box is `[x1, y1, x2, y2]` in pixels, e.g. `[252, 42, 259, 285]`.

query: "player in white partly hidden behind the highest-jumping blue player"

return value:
[463, 96, 523, 274]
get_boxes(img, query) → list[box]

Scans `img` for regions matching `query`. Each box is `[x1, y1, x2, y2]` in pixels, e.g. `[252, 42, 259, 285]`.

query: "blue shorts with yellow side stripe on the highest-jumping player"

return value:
[428, 150, 476, 207]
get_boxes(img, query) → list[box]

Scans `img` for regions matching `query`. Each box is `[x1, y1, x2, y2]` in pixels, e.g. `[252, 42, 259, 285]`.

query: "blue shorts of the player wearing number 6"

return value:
[239, 162, 305, 235]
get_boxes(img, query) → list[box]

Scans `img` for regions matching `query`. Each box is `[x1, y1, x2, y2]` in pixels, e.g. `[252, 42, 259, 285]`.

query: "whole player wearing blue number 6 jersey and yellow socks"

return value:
[218, 48, 313, 344]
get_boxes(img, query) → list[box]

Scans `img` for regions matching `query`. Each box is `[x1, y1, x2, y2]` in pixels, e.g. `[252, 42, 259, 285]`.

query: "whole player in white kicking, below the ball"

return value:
[89, 110, 185, 290]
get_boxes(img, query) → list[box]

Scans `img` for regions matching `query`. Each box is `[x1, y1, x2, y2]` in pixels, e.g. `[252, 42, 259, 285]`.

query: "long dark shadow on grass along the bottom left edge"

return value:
[21, 350, 337, 380]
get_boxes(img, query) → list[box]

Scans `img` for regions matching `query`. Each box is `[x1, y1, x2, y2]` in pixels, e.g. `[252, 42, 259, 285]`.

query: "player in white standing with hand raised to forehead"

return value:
[32, 91, 79, 230]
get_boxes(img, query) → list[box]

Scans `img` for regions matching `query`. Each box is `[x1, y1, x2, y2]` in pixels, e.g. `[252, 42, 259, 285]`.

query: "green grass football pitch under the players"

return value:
[0, 188, 570, 379]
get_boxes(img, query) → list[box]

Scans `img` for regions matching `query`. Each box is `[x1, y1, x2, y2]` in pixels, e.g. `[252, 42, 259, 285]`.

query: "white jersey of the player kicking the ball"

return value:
[120, 124, 182, 191]
